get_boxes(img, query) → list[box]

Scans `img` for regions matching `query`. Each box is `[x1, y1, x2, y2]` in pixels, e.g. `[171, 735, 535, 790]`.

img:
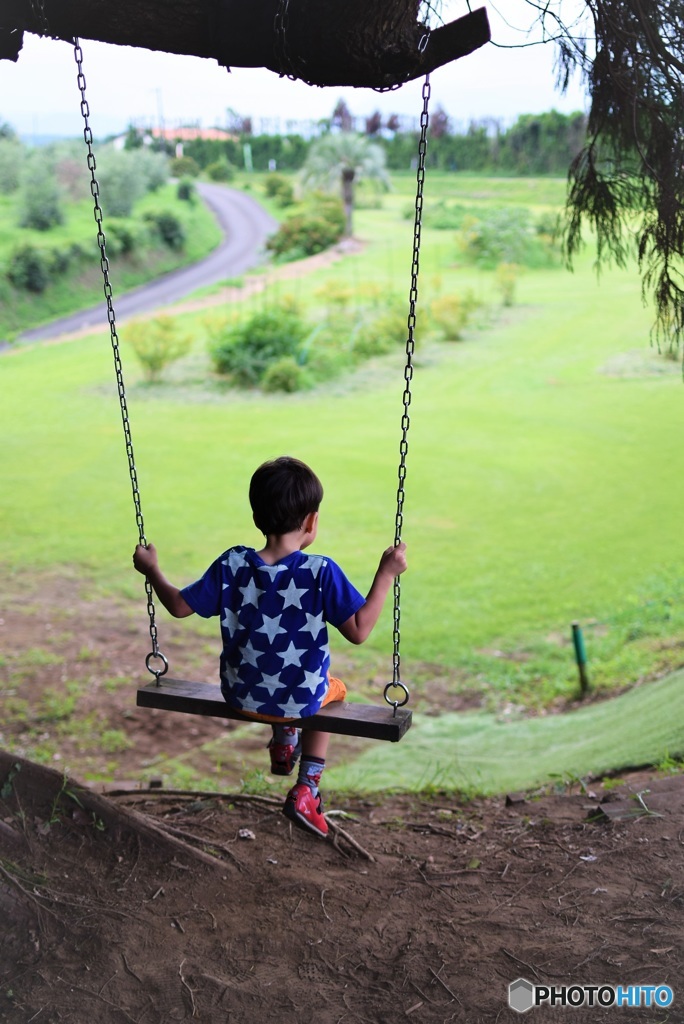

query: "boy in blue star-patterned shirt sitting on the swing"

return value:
[133, 456, 407, 838]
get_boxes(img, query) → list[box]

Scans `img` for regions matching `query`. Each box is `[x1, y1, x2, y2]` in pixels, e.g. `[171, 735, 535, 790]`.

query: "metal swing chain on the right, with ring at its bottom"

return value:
[384, 75, 430, 715]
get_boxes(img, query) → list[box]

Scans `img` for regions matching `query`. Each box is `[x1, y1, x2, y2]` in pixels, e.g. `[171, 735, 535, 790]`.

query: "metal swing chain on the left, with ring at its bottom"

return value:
[74, 38, 169, 686]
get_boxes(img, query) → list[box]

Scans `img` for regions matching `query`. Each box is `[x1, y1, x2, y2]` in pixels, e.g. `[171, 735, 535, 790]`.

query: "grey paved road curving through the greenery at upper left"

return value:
[16, 182, 277, 343]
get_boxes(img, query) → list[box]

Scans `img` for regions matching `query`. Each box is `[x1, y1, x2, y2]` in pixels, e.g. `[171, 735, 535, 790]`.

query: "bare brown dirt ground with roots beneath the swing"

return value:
[0, 574, 684, 1024]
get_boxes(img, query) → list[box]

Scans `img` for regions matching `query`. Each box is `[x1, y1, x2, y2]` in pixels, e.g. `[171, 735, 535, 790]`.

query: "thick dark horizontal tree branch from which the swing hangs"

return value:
[0, 0, 489, 89]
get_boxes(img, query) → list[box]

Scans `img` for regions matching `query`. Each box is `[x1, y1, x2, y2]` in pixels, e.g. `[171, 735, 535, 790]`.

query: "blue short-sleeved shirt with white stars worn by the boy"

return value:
[181, 546, 366, 718]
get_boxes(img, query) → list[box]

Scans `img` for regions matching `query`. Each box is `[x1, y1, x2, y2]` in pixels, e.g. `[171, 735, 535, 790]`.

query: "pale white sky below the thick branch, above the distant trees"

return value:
[0, 0, 588, 138]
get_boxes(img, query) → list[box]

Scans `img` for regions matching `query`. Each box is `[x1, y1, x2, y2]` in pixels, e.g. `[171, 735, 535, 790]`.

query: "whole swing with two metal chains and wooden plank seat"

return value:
[74, 39, 430, 742]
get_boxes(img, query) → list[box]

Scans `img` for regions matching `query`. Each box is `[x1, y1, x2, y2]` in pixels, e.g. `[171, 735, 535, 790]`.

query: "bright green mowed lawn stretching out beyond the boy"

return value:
[0, 175, 684, 729]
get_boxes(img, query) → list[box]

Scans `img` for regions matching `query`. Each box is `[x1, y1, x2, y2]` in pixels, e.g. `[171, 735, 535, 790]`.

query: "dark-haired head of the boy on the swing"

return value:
[250, 455, 323, 537]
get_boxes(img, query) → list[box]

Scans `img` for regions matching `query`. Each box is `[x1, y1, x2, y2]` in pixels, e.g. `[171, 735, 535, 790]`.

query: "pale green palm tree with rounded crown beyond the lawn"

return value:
[302, 132, 389, 238]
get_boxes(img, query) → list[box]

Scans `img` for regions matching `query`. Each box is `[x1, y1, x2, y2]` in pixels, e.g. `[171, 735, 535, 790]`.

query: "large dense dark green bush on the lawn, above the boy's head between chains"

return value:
[210, 302, 308, 387]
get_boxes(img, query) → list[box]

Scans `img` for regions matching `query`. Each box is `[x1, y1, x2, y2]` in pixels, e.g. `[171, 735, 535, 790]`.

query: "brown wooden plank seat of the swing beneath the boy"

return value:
[136, 679, 413, 743]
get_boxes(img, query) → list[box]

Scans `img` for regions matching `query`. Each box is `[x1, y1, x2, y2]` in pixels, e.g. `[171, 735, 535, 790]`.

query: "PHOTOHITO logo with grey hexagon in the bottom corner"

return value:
[508, 978, 675, 1014]
